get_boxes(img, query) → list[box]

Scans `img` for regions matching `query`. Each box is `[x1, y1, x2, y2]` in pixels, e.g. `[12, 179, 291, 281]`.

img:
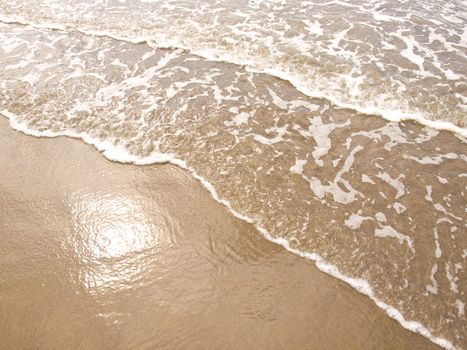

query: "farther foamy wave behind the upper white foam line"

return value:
[0, 0, 467, 136]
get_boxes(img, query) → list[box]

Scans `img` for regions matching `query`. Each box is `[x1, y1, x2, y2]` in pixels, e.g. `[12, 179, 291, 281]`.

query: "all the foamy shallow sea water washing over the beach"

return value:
[0, 0, 467, 348]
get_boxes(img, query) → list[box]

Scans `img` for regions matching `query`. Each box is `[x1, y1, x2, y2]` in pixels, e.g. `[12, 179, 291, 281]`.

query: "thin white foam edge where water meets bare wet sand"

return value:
[0, 110, 458, 350]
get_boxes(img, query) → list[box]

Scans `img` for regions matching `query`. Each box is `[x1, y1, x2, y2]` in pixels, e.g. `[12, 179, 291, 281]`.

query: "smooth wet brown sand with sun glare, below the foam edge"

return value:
[0, 118, 438, 349]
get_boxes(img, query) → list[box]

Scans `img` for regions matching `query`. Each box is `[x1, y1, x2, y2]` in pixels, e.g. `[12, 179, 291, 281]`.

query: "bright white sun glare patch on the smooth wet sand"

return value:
[68, 194, 165, 294]
